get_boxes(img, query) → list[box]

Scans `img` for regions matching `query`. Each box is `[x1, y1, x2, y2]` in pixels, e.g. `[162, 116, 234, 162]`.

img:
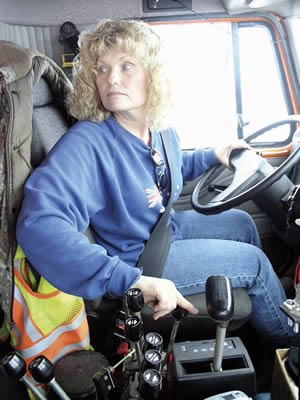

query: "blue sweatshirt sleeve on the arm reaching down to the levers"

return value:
[16, 123, 141, 299]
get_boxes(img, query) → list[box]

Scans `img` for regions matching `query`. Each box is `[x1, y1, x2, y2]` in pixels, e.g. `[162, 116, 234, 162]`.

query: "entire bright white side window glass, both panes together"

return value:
[153, 20, 289, 149]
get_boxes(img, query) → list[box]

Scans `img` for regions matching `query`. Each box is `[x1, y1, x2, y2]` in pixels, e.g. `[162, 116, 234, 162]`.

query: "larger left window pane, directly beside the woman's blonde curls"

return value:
[154, 22, 237, 149]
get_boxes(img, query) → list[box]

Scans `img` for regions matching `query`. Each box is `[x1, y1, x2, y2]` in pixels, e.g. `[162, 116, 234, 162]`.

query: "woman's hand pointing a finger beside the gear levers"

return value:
[132, 275, 198, 320]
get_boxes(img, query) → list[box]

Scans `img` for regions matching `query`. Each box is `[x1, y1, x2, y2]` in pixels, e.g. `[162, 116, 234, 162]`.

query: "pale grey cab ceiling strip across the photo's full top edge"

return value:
[0, 0, 300, 26]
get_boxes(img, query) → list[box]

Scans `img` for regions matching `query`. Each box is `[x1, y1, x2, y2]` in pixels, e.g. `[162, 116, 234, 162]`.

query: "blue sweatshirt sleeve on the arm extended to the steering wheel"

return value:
[182, 149, 217, 181]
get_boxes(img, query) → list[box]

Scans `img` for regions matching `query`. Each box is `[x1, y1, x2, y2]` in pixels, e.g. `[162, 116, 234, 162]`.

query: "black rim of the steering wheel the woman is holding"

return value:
[192, 115, 300, 214]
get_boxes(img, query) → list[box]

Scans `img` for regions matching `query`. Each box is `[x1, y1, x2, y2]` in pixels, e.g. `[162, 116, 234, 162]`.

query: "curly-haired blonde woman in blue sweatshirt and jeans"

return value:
[17, 20, 293, 344]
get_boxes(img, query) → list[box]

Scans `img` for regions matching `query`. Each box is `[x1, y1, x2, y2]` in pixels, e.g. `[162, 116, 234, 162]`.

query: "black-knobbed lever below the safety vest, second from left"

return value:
[28, 355, 71, 400]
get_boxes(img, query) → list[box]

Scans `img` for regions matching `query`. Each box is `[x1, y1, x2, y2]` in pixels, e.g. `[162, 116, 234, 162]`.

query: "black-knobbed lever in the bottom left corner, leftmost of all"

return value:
[1, 351, 47, 400]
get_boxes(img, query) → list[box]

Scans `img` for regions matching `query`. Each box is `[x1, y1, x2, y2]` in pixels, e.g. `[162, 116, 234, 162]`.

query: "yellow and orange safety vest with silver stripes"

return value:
[11, 248, 90, 377]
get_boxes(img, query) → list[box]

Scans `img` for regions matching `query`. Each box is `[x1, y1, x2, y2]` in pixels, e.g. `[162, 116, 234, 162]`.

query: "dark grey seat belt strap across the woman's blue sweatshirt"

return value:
[137, 131, 175, 278]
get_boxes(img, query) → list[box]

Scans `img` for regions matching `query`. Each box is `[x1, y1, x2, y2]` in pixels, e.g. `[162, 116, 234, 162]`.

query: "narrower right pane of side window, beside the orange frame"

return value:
[239, 26, 290, 142]
